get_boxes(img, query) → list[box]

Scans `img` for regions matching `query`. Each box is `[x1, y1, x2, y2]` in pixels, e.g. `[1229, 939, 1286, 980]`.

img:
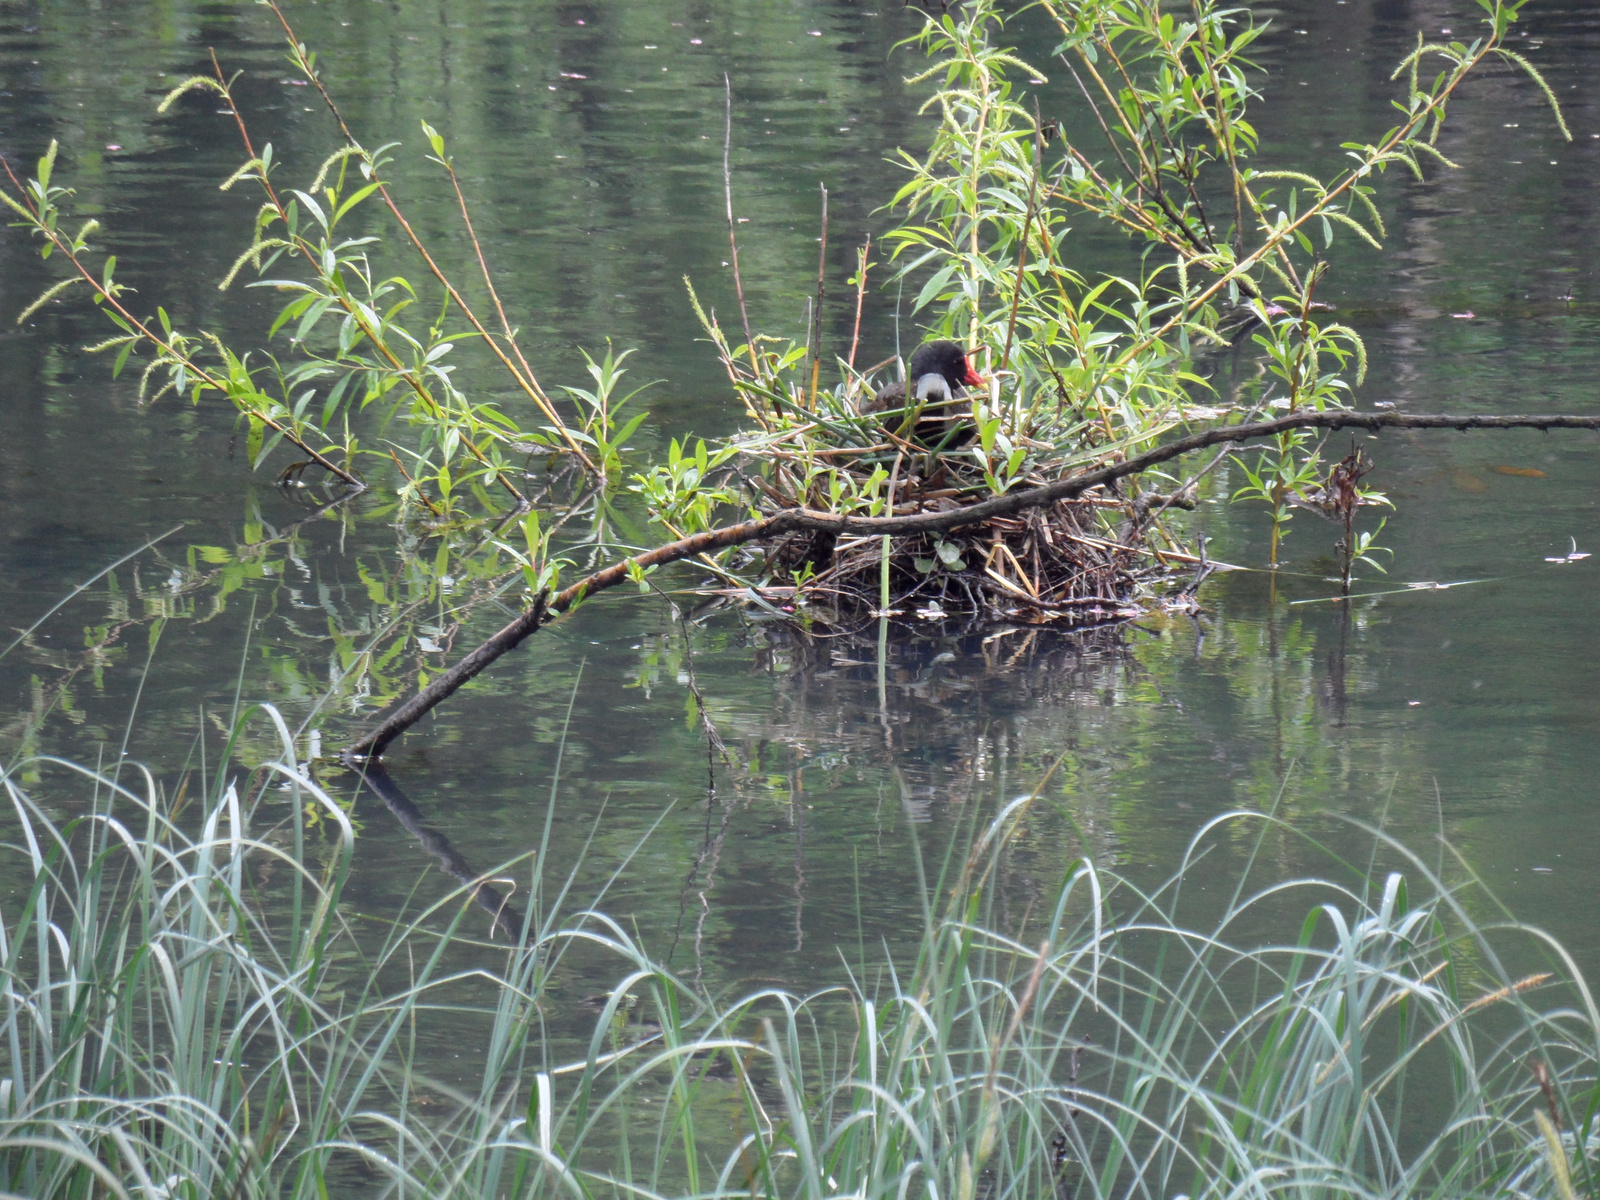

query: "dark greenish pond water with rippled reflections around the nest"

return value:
[0, 0, 1600, 1017]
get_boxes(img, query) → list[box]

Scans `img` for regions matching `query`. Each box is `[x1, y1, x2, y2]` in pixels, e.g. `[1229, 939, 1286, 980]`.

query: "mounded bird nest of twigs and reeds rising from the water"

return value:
[726, 366, 1194, 626]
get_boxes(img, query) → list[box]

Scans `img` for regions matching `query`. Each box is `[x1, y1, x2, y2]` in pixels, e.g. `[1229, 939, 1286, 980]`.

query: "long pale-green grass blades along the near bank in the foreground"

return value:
[0, 714, 1600, 1200]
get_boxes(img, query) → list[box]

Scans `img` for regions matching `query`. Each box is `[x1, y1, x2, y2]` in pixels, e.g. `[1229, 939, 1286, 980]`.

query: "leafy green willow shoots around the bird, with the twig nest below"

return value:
[659, 0, 1566, 614]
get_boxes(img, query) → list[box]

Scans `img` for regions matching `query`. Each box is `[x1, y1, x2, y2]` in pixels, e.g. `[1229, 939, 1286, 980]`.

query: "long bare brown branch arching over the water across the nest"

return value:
[346, 411, 1600, 758]
